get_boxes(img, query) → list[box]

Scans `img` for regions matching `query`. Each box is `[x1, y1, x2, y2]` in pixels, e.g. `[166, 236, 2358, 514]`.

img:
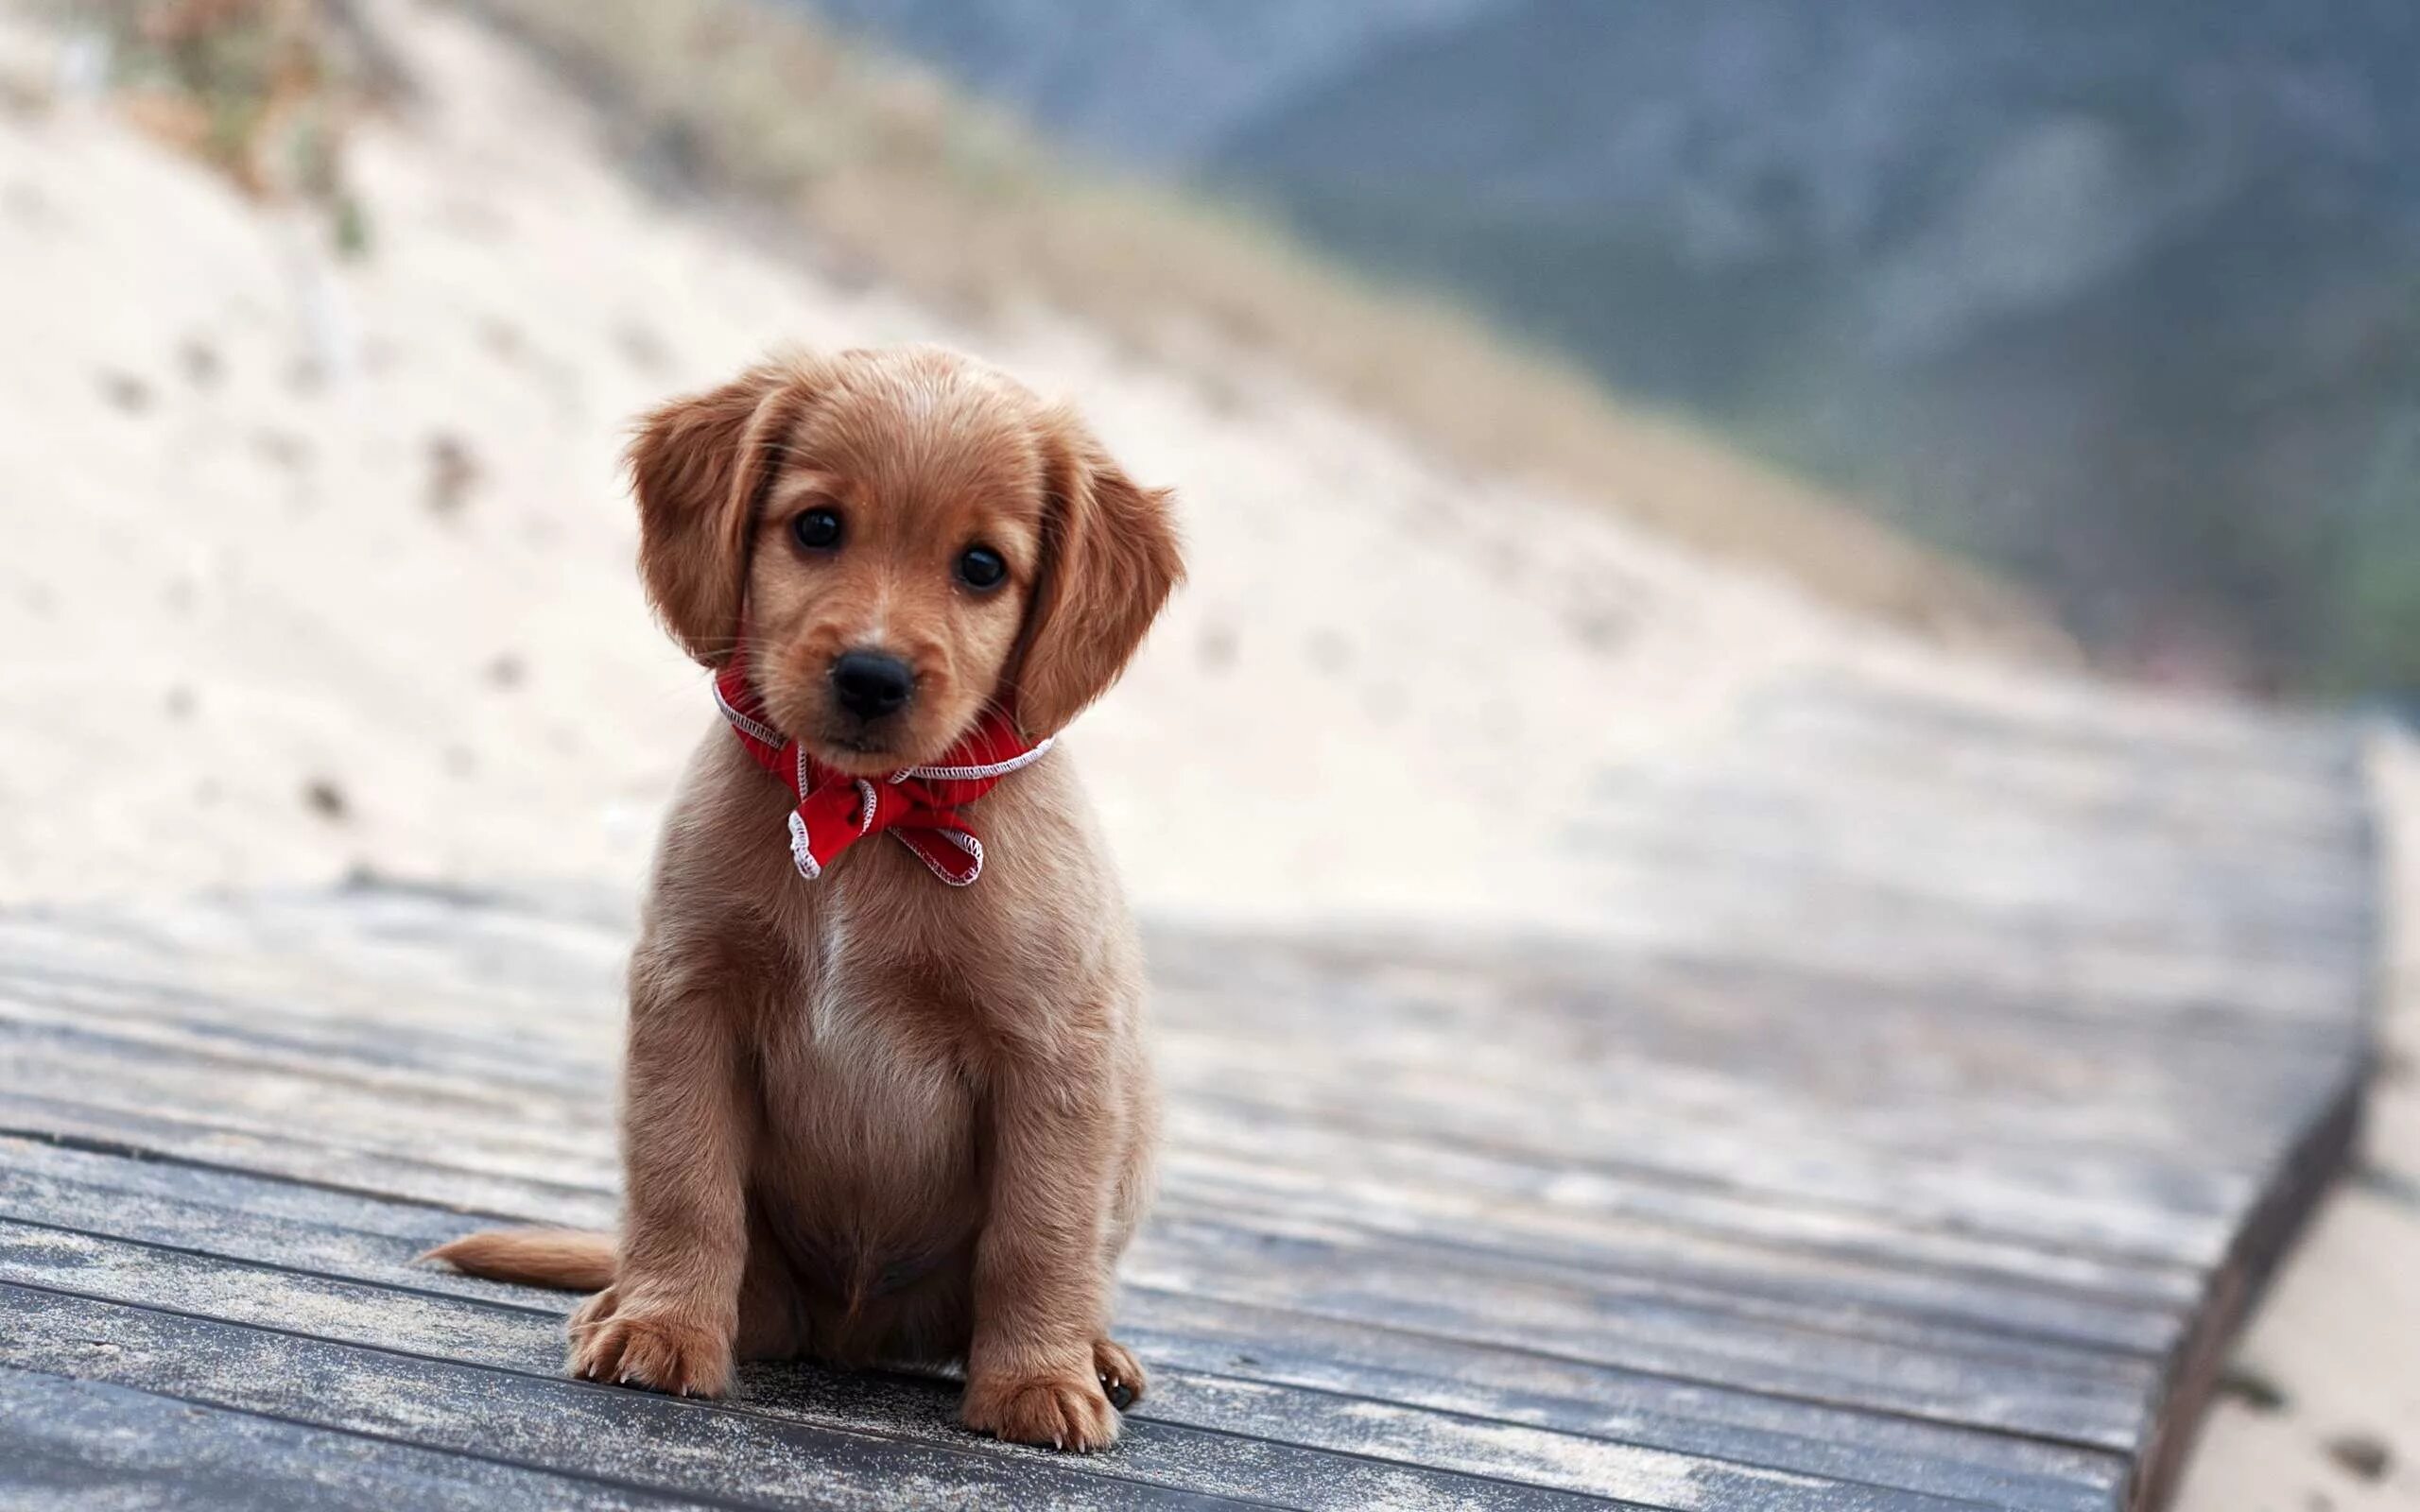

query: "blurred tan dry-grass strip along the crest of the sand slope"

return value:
[445, 0, 2074, 661]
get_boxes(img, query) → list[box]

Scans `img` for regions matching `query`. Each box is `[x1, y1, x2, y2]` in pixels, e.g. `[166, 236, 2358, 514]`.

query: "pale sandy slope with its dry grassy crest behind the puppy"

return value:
[0, 0, 1926, 914]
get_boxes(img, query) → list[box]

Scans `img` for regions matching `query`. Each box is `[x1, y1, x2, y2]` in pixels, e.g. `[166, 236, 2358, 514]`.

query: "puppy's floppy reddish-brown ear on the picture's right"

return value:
[1014, 409, 1185, 738]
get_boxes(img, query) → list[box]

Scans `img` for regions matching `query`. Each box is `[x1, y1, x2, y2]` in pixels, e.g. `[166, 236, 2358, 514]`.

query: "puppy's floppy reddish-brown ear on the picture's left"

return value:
[630, 363, 808, 668]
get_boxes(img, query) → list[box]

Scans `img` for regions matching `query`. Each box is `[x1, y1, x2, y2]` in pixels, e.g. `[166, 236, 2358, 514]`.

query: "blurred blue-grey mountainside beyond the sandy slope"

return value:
[816, 0, 2420, 690]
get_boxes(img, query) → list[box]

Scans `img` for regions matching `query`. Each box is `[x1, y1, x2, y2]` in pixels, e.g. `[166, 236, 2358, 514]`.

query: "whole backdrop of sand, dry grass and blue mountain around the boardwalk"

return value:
[0, 0, 2420, 1509]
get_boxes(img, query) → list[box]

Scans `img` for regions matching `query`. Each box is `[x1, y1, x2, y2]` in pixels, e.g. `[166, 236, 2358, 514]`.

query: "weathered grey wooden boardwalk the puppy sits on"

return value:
[0, 682, 2377, 1512]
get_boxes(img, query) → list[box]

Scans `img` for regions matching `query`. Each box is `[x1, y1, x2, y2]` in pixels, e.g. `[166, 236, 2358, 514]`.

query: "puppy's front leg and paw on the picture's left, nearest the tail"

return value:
[571, 962, 748, 1396]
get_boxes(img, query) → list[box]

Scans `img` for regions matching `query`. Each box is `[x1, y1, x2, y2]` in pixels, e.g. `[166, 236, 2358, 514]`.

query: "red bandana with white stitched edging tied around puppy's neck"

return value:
[714, 648, 1050, 888]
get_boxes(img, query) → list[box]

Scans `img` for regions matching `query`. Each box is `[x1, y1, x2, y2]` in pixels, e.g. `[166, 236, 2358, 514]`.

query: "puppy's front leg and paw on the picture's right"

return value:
[960, 1067, 1142, 1452]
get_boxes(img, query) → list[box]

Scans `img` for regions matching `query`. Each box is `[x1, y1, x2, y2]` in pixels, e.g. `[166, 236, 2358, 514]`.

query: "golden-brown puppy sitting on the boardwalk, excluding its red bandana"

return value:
[433, 349, 1181, 1449]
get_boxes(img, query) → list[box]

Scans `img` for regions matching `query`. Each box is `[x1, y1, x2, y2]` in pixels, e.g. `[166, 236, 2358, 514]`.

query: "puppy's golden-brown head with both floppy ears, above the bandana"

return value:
[630, 346, 1184, 774]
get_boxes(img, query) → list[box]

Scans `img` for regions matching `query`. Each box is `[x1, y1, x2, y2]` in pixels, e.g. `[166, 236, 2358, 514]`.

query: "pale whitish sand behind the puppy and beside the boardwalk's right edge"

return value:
[0, 8, 2420, 1509]
